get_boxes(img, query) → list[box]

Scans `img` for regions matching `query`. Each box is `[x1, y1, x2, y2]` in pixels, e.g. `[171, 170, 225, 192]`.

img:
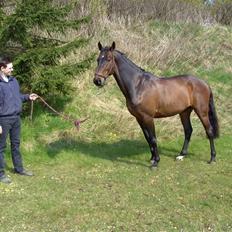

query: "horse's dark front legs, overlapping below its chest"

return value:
[137, 118, 160, 167]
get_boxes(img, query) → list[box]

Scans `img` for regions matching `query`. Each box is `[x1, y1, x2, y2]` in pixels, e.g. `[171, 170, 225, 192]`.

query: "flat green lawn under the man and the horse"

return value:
[0, 119, 232, 232]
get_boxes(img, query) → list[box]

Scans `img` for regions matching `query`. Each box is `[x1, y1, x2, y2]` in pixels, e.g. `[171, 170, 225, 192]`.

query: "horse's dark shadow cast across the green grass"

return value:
[47, 138, 188, 166]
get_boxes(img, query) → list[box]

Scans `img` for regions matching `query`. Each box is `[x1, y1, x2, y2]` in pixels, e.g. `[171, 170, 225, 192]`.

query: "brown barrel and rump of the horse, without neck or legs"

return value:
[135, 75, 210, 117]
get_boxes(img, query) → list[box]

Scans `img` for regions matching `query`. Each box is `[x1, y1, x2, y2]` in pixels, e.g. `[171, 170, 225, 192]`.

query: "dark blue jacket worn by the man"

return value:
[0, 76, 29, 118]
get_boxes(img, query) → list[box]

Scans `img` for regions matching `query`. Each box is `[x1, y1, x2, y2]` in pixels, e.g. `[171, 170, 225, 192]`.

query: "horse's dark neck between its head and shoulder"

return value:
[114, 53, 142, 100]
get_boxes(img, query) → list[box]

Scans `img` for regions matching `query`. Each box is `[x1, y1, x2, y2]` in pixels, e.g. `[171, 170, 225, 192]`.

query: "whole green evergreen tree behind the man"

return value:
[0, 0, 93, 99]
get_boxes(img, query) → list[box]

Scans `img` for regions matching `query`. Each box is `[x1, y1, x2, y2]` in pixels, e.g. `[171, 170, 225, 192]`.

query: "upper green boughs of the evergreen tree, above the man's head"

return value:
[0, 0, 90, 48]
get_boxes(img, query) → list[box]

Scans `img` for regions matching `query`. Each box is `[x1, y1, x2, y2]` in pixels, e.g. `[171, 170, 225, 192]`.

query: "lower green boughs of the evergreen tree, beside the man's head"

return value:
[12, 39, 93, 95]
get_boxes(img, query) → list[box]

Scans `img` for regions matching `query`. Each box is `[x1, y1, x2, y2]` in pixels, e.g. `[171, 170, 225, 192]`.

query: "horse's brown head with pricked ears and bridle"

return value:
[93, 42, 115, 87]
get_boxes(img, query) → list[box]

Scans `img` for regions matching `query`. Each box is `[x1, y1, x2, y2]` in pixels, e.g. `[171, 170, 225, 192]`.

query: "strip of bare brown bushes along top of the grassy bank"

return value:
[105, 0, 232, 25]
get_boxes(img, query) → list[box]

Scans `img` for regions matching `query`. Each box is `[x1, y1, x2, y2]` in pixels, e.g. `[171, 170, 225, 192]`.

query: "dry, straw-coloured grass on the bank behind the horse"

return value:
[52, 0, 232, 140]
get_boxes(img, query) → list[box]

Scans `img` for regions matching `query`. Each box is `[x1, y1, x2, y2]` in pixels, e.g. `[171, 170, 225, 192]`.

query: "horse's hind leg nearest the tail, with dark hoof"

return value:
[196, 109, 216, 163]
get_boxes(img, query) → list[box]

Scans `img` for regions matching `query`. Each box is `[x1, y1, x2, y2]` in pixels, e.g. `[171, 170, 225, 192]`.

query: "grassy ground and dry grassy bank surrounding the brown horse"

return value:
[0, 16, 232, 232]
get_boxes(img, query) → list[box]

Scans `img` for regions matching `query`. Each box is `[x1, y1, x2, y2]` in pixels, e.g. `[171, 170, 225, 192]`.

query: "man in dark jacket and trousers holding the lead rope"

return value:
[0, 58, 38, 184]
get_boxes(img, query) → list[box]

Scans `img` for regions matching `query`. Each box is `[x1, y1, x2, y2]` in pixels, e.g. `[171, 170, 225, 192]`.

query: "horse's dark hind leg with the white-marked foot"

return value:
[176, 108, 193, 160]
